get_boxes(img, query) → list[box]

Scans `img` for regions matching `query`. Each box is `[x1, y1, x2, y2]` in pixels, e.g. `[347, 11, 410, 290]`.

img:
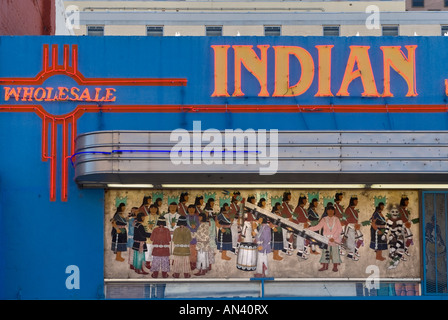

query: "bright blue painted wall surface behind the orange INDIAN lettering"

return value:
[0, 37, 448, 299]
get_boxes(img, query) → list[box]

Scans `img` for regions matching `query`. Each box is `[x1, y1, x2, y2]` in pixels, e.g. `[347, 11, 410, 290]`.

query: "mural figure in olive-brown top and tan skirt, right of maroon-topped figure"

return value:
[173, 216, 192, 278]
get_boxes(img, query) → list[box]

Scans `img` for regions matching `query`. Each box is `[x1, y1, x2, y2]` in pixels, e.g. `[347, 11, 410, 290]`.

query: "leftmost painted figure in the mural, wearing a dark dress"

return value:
[111, 203, 128, 262]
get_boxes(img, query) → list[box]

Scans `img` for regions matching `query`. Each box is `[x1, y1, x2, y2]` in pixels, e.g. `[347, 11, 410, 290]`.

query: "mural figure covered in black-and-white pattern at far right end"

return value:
[386, 206, 406, 269]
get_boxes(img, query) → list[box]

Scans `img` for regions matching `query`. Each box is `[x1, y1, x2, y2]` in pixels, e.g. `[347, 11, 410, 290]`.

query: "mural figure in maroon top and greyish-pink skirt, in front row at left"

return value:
[150, 217, 171, 278]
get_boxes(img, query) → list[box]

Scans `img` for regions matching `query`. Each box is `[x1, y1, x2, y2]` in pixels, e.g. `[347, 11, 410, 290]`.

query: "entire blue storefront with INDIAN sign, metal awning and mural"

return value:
[0, 37, 448, 299]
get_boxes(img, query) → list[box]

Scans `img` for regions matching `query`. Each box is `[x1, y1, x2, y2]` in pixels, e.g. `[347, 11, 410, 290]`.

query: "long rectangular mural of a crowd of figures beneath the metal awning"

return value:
[104, 189, 420, 279]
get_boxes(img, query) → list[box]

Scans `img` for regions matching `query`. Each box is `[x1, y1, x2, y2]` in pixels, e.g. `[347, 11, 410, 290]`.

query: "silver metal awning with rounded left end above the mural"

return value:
[72, 130, 448, 187]
